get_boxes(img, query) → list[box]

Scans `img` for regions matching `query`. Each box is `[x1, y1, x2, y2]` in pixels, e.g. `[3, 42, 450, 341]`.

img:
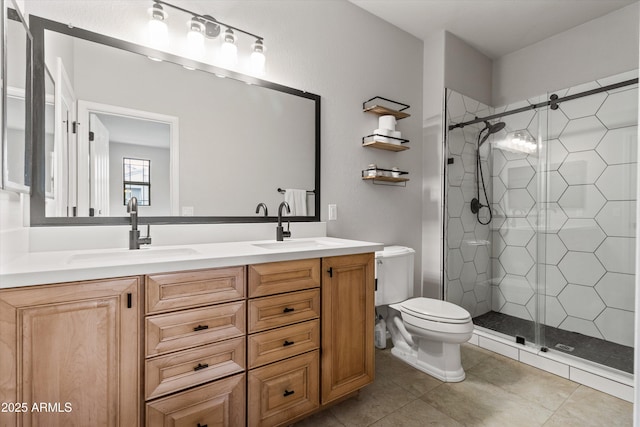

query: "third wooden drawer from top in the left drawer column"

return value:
[145, 337, 245, 399]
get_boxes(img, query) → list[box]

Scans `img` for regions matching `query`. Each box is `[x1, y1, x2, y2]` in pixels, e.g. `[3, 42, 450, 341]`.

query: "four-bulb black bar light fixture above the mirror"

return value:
[149, 0, 266, 75]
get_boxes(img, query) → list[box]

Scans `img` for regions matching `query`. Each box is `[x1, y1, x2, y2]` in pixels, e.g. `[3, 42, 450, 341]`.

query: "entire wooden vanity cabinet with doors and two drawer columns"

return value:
[0, 253, 374, 427]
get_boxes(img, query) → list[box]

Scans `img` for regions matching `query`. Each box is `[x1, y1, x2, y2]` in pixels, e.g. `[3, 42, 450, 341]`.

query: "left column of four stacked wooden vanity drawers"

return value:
[144, 266, 247, 427]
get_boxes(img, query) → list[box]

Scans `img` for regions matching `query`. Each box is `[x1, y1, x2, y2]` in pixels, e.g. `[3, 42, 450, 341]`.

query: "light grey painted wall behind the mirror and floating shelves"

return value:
[11, 0, 423, 292]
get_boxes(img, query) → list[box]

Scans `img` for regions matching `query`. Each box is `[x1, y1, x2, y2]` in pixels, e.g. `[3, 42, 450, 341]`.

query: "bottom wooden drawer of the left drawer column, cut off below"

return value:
[146, 374, 245, 427]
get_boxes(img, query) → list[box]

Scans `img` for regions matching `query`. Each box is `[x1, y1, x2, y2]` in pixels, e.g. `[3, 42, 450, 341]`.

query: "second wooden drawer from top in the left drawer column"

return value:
[146, 301, 246, 357]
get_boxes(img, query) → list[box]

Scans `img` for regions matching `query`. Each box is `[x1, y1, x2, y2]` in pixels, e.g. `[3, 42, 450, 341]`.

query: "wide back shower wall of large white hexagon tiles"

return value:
[491, 70, 638, 346]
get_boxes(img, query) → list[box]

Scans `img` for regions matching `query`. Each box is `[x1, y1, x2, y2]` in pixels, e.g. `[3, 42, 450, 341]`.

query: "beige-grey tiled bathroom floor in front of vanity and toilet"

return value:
[295, 344, 633, 427]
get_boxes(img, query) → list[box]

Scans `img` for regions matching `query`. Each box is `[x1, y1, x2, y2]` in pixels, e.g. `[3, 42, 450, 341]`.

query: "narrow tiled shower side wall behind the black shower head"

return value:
[445, 90, 491, 316]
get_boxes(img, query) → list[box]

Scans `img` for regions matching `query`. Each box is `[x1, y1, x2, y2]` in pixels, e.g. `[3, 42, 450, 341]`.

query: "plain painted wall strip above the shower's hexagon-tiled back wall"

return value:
[491, 3, 639, 106]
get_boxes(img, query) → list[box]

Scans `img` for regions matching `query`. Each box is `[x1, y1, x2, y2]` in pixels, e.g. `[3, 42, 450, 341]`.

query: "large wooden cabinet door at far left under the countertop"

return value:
[0, 277, 142, 427]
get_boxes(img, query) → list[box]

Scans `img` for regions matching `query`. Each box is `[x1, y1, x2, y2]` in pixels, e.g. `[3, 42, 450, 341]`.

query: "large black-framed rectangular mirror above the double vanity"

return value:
[30, 16, 320, 225]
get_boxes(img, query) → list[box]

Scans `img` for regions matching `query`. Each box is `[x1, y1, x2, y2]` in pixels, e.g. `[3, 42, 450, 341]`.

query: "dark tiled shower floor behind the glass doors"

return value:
[473, 311, 633, 374]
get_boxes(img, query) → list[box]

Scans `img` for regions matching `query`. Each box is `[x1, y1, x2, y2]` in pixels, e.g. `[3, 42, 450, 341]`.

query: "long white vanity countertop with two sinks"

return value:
[0, 237, 383, 289]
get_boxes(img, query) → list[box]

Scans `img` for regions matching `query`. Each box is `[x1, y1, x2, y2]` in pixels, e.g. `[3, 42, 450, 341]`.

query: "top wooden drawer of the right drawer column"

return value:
[248, 259, 320, 298]
